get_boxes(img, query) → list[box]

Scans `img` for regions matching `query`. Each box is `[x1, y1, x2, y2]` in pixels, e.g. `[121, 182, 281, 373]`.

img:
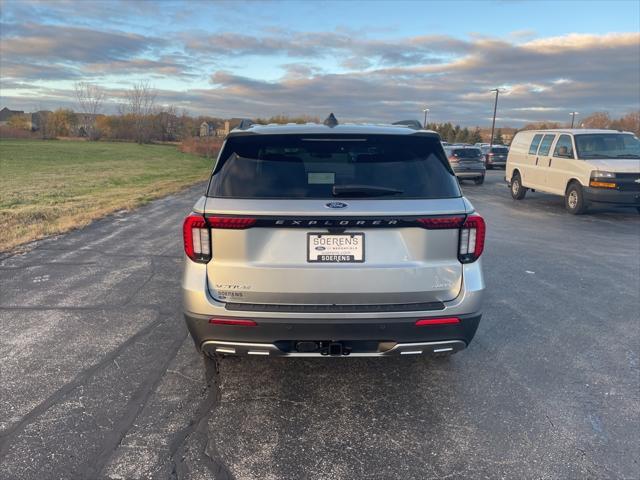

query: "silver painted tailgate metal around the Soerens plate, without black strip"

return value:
[203, 198, 466, 305]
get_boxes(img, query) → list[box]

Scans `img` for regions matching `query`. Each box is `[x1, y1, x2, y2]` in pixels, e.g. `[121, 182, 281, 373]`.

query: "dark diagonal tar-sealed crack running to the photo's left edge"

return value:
[0, 312, 166, 459]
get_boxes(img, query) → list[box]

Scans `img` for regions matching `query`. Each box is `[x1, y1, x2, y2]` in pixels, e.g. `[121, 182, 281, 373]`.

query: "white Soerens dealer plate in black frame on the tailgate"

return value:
[307, 233, 364, 263]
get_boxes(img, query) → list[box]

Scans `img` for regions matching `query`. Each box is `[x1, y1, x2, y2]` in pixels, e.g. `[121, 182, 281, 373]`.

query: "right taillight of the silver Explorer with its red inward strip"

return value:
[417, 215, 486, 263]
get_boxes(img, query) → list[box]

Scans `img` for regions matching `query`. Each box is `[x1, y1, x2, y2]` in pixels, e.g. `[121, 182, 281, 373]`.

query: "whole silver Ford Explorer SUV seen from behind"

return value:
[182, 116, 485, 357]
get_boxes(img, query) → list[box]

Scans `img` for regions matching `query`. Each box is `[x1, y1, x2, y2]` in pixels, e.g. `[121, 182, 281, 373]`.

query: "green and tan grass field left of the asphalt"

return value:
[0, 140, 212, 251]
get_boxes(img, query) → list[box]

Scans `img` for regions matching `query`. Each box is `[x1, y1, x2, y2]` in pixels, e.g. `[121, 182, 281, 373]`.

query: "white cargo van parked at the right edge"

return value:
[505, 129, 640, 214]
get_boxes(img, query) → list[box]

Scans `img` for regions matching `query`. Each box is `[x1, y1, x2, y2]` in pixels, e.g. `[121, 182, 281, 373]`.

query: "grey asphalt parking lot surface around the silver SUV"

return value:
[0, 171, 640, 479]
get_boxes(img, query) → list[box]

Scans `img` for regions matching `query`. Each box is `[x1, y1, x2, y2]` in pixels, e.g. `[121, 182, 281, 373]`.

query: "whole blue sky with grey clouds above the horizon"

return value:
[0, 0, 640, 126]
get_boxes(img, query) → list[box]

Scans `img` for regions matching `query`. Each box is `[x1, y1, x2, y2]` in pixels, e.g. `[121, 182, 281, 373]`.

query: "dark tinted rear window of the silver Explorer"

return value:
[208, 134, 461, 199]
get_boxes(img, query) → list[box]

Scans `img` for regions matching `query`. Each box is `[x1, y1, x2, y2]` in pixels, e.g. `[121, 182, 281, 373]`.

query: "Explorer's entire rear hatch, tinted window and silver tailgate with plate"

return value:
[204, 134, 466, 305]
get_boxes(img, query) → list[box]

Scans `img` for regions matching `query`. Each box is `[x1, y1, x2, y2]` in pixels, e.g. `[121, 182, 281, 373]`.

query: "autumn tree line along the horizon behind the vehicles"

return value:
[3, 82, 640, 144]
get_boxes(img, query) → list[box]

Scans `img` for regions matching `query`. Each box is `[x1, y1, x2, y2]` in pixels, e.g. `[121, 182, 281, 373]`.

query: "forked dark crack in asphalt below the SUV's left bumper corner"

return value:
[169, 356, 233, 480]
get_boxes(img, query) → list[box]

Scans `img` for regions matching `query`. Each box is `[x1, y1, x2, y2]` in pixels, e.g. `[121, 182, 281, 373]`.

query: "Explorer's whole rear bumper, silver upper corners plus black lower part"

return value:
[182, 259, 485, 356]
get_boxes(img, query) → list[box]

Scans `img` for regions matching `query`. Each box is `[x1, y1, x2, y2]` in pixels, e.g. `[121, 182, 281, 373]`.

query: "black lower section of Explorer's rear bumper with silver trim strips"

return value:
[185, 314, 481, 357]
